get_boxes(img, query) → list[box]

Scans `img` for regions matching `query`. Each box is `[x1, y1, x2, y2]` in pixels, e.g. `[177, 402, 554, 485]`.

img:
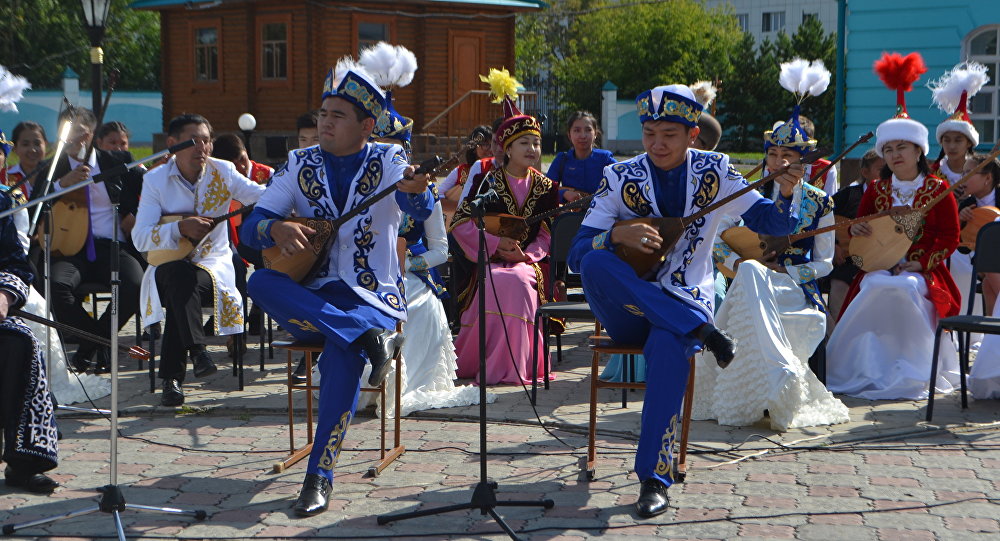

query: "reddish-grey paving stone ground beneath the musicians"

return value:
[0, 318, 1000, 541]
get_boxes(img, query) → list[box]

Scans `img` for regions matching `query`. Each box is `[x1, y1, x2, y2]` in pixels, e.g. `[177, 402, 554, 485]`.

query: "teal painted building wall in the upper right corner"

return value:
[844, 0, 1000, 159]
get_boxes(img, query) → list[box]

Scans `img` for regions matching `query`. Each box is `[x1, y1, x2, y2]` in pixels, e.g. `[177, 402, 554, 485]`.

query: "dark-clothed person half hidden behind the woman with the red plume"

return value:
[821, 149, 885, 324]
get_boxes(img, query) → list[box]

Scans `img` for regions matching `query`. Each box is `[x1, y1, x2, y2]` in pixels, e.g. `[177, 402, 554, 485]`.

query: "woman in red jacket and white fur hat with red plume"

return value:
[826, 53, 961, 400]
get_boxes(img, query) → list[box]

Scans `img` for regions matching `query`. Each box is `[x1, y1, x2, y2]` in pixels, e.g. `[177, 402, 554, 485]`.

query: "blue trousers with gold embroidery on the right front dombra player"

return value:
[580, 250, 708, 487]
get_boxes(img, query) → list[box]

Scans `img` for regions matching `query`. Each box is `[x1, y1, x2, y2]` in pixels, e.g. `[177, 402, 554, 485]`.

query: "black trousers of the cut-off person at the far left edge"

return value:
[0, 332, 55, 474]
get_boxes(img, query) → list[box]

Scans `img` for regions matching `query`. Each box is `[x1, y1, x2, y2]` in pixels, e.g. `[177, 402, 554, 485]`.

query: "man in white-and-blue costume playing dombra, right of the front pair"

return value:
[569, 85, 803, 517]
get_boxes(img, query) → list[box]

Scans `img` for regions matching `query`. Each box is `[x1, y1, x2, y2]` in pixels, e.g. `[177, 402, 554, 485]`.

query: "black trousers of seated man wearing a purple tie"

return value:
[52, 239, 142, 352]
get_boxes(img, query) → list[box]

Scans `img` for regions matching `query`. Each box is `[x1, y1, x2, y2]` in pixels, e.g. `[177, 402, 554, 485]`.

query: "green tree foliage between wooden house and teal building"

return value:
[516, 0, 836, 151]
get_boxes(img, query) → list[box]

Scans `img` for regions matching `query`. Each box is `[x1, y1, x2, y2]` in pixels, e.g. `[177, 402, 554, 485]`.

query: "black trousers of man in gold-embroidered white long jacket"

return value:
[156, 261, 214, 382]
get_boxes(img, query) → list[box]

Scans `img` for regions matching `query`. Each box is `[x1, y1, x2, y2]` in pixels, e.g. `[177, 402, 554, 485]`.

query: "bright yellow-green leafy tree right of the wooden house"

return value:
[554, 0, 742, 119]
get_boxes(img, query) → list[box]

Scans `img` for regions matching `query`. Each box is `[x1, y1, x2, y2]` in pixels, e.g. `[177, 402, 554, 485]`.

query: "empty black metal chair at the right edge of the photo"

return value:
[927, 222, 1000, 422]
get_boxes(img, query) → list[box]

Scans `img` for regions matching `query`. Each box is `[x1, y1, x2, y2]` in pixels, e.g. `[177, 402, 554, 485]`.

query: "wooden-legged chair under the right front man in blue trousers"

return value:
[586, 322, 695, 483]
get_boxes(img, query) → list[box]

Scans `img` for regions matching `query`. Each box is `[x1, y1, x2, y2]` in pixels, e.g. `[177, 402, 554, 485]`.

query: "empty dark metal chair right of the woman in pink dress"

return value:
[531, 212, 594, 404]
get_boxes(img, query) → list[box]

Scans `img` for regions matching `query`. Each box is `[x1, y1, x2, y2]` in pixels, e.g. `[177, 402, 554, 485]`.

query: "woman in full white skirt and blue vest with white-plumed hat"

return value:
[693, 106, 849, 430]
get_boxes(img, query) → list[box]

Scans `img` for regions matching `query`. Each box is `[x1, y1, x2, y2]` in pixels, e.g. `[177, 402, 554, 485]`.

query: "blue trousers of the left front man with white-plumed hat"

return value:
[247, 269, 396, 482]
